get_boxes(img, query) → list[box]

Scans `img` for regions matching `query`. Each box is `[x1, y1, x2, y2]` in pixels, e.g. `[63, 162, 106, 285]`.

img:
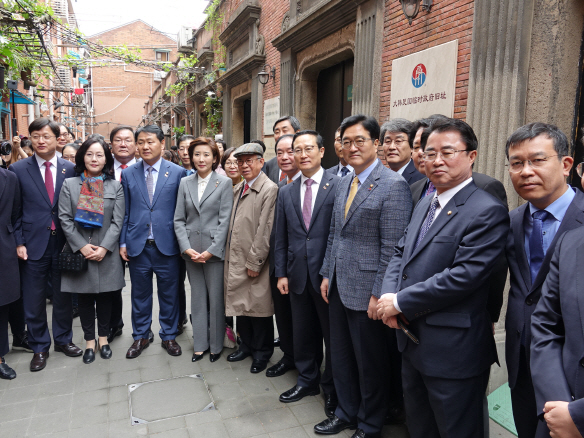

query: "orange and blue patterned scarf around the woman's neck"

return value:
[75, 171, 105, 228]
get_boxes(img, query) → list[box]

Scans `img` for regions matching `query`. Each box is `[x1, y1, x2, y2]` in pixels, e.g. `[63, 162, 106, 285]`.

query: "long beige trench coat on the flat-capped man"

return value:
[224, 172, 278, 317]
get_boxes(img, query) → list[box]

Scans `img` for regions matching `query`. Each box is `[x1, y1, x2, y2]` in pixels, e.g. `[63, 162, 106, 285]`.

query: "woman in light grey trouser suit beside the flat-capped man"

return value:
[174, 137, 233, 362]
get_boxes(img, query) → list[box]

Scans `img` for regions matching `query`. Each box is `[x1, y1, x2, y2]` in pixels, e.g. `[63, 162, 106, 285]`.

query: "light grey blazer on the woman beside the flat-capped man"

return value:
[174, 172, 233, 262]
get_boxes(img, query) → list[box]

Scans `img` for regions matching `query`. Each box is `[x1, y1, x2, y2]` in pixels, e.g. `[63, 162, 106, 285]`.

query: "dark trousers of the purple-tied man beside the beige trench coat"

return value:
[290, 280, 335, 395]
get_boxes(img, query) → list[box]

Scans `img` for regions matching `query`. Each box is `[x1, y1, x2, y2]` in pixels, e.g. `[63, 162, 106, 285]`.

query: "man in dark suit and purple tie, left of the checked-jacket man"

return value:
[274, 131, 340, 418]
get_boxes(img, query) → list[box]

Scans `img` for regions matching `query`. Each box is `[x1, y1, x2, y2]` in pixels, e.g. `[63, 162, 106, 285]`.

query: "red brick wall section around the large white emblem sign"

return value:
[379, 0, 474, 121]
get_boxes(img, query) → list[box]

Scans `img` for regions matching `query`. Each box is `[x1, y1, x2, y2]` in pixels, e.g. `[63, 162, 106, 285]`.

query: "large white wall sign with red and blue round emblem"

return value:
[390, 40, 458, 121]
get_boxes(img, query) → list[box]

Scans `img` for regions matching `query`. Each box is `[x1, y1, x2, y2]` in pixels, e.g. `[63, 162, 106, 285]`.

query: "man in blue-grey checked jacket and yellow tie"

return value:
[314, 115, 412, 437]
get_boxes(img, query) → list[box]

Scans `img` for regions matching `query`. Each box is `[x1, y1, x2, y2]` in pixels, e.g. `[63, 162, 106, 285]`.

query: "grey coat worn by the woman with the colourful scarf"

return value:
[59, 177, 126, 293]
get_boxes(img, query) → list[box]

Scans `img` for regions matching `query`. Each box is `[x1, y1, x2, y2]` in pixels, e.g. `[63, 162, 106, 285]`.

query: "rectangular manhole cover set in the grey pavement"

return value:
[128, 374, 215, 425]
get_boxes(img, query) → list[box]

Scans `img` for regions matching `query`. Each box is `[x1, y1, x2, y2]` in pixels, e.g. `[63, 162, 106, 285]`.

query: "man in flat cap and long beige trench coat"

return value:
[225, 143, 278, 373]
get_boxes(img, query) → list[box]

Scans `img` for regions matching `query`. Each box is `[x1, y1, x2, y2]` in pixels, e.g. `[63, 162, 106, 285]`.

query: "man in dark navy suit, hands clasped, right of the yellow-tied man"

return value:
[378, 119, 509, 438]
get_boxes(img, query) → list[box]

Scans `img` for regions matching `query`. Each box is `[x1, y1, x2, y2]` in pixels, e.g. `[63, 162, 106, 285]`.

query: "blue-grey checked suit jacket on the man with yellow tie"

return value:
[320, 161, 412, 311]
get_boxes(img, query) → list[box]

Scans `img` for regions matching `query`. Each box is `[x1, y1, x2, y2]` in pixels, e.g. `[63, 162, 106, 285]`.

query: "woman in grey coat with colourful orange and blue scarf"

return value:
[59, 136, 125, 363]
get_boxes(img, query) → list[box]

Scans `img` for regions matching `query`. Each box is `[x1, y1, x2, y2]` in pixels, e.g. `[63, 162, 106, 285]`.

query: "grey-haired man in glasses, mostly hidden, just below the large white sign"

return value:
[380, 119, 425, 185]
